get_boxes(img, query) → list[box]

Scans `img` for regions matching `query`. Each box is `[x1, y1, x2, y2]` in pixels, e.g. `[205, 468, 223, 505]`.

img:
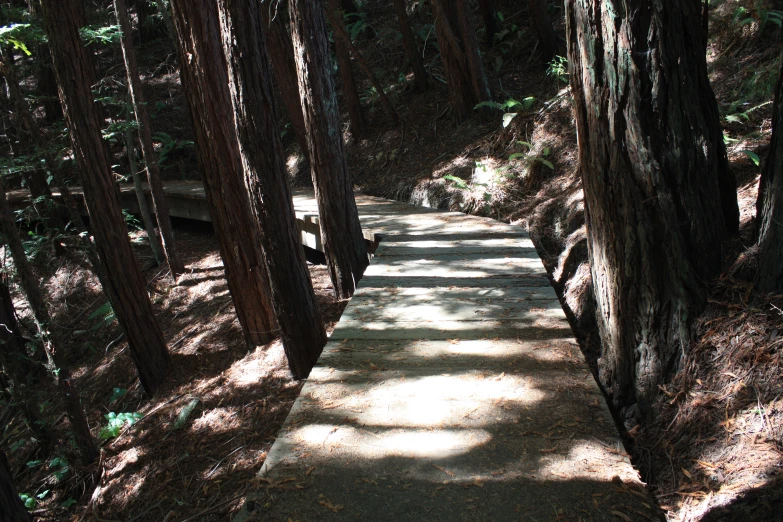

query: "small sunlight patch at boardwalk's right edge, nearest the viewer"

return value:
[534, 440, 640, 483]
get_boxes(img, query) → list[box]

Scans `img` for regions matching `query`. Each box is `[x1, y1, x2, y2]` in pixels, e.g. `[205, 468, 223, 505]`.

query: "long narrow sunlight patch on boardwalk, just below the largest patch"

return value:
[289, 424, 492, 459]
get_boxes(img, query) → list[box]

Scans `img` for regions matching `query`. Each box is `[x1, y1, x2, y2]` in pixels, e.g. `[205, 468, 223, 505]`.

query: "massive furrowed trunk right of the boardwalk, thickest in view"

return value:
[566, 0, 738, 417]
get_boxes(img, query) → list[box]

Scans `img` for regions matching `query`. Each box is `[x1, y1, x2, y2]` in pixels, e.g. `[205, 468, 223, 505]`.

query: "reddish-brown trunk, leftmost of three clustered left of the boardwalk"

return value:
[171, 0, 277, 346]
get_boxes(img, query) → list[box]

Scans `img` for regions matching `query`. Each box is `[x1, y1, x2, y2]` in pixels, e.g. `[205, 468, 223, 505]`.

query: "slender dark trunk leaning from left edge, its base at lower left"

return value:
[0, 181, 98, 463]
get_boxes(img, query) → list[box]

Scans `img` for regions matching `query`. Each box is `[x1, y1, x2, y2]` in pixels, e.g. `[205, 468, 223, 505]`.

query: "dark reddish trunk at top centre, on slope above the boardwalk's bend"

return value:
[432, 0, 491, 122]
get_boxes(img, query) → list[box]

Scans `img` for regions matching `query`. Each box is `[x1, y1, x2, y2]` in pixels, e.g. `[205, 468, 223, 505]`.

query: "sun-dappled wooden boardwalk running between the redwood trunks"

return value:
[234, 192, 660, 521]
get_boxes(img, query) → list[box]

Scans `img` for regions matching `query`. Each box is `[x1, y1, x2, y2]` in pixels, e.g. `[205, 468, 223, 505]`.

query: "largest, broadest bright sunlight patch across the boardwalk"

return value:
[302, 371, 547, 428]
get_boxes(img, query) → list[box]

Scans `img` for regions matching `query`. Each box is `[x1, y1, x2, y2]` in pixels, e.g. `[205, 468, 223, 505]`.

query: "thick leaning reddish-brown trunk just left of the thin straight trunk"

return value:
[42, 0, 169, 395]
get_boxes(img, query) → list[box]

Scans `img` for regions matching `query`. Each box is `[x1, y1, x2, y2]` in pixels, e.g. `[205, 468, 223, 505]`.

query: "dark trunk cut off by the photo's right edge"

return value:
[756, 56, 783, 293]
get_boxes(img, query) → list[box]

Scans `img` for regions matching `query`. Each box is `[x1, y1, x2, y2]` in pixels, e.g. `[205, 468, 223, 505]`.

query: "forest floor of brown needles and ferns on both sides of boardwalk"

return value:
[2, 1, 783, 522]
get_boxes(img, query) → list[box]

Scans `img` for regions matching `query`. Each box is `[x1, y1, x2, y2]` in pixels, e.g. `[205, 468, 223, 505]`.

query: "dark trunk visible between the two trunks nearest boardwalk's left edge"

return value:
[261, 2, 308, 156]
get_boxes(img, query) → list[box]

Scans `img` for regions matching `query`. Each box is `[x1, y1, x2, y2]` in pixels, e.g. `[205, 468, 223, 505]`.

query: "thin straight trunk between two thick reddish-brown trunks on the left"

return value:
[114, 0, 185, 278]
